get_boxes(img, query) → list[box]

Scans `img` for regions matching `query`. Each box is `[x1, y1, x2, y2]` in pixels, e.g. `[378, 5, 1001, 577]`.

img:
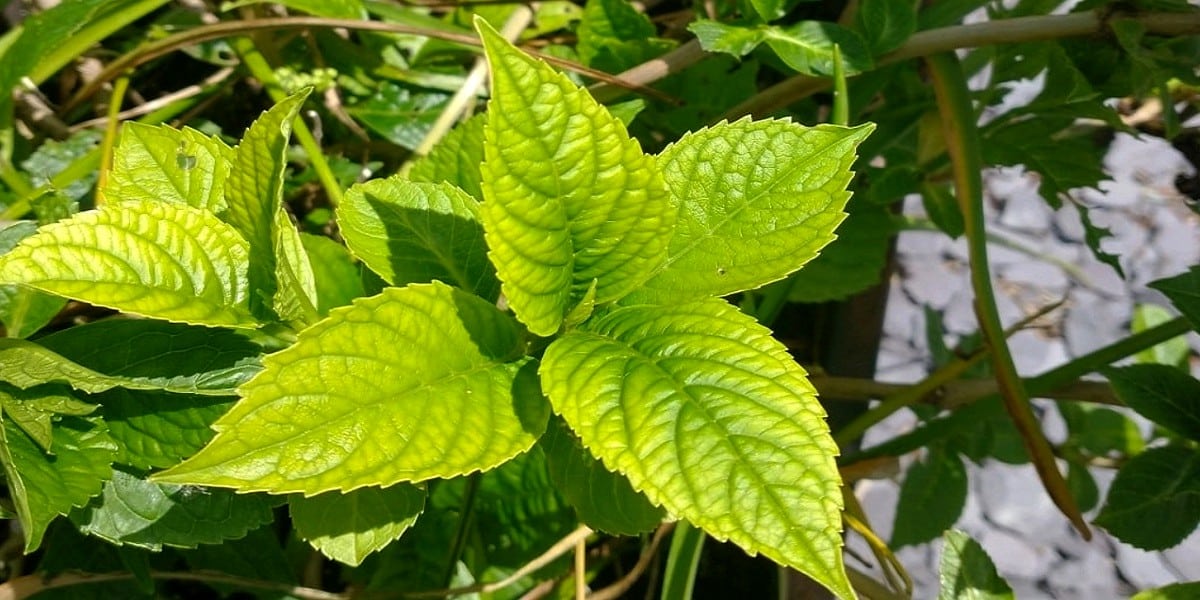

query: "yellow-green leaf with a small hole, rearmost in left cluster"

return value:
[103, 122, 233, 214]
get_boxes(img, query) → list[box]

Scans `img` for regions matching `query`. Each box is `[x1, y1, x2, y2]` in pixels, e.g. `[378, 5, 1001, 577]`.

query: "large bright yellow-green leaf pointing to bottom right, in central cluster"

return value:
[541, 299, 853, 598]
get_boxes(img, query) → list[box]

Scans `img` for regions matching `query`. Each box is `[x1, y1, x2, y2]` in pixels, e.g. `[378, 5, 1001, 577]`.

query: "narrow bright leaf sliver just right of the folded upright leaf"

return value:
[272, 206, 320, 329]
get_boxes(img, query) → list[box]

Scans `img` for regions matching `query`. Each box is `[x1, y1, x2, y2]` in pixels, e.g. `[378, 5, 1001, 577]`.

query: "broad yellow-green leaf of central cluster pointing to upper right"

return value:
[626, 119, 872, 304]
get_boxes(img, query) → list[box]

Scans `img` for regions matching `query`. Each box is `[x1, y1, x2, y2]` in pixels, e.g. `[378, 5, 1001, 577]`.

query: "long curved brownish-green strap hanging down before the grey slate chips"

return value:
[926, 53, 1092, 539]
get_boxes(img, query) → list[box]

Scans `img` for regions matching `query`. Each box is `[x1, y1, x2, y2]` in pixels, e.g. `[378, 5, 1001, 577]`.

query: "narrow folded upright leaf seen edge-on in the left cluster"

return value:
[223, 89, 308, 320]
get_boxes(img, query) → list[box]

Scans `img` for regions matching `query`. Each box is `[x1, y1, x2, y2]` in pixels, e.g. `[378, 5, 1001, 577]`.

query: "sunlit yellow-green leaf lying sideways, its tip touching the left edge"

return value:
[0, 202, 256, 328]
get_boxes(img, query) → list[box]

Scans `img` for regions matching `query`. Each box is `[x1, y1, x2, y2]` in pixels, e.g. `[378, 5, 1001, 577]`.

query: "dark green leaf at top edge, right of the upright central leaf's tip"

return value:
[575, 0, 674, 73]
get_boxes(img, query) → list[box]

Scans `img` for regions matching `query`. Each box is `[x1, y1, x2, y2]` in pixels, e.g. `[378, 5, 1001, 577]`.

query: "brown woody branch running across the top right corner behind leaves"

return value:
[722, 11, 1200, 121]
